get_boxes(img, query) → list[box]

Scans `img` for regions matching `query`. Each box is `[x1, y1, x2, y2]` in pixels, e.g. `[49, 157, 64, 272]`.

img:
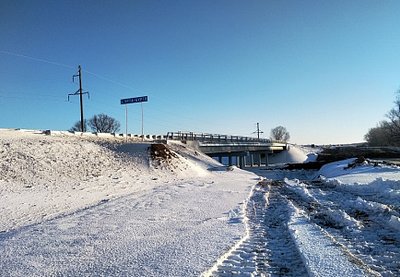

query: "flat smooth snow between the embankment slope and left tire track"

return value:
[0, 177, 251, 276]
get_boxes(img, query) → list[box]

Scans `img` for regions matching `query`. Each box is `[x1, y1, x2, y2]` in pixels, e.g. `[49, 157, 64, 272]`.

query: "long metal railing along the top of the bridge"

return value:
[166, 132, 272, 143]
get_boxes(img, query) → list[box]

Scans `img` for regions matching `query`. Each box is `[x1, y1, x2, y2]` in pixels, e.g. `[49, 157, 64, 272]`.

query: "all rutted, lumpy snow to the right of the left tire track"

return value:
[250, 159, 400, 276]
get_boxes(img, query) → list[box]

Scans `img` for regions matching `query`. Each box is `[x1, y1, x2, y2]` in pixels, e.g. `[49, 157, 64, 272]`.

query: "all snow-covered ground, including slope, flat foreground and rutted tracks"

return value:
[0, 130, 400, 276]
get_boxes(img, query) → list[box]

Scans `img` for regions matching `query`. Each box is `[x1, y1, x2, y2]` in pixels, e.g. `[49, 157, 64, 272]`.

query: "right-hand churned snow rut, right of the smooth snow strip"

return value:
[283, 181, 392, 276]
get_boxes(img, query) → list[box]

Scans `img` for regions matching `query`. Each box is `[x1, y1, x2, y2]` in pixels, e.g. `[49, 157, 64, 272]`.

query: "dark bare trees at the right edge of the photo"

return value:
[364, 90, 400, 146]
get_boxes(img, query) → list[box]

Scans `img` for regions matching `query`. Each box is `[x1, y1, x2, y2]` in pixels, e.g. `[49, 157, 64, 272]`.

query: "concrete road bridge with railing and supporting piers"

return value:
[166, 132, 288, 168]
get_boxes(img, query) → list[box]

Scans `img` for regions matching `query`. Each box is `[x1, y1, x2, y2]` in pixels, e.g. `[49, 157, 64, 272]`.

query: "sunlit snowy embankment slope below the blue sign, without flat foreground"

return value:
[0, 130, 225, 231]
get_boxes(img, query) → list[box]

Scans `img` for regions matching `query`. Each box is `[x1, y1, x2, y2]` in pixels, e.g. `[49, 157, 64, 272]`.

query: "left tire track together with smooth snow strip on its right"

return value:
[205, 181, 375, 276]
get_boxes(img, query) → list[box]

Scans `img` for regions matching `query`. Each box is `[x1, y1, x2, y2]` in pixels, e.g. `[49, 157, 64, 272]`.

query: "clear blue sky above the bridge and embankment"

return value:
[0, 0, 400, 144]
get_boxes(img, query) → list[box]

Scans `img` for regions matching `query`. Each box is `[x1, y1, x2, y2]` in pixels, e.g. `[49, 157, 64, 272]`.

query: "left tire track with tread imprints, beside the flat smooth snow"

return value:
[206, 182, 307, 276]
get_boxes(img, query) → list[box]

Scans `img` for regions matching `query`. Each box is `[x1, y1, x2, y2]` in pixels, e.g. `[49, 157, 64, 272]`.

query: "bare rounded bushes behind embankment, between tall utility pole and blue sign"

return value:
[69, 114, 121, 133]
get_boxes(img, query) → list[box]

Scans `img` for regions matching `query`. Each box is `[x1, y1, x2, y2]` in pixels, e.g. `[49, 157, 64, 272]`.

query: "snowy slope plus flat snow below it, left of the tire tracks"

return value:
[0, 130, 257, 276]
